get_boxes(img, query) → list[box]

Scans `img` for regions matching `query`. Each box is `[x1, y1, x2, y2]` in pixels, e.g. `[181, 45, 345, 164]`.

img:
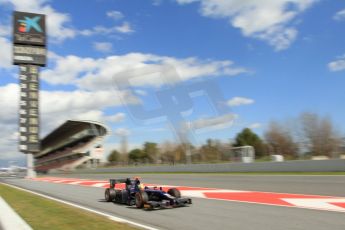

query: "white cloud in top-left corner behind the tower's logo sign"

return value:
[0, 0, 76, 42]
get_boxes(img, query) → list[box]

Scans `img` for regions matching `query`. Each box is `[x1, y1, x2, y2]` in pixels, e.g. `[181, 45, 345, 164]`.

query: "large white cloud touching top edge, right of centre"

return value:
[176, 0, 317, 51]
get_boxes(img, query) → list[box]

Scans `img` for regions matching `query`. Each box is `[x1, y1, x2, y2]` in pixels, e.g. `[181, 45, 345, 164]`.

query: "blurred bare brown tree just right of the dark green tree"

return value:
[265, 122, 298, 157]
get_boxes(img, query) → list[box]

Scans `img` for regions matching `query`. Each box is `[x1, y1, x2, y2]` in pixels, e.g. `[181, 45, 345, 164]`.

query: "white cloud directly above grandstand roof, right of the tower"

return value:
[40, 90, 138, 134]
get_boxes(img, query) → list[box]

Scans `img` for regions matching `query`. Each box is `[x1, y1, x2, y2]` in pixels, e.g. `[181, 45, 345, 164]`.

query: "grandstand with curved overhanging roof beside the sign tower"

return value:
[34, 120, 109, 173]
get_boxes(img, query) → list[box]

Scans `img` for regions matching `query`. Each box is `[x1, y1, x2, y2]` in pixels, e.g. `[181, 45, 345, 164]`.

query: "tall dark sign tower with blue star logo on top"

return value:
[13, 11, 47, 177]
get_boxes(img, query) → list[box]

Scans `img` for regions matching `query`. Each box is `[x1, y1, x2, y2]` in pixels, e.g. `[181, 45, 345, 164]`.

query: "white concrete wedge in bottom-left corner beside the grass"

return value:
[0, 196, 32, 230]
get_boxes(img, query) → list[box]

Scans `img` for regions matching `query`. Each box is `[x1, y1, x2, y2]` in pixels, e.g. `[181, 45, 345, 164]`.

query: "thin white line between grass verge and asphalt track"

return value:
[0, 182, 159, 230]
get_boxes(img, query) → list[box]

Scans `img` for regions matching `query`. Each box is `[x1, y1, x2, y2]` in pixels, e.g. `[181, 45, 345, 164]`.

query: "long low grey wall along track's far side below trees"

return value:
[72, 159, 345, 173]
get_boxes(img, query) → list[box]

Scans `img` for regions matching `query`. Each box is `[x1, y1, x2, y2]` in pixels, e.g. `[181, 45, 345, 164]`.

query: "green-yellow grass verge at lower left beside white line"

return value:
[0, 184, 136, 230]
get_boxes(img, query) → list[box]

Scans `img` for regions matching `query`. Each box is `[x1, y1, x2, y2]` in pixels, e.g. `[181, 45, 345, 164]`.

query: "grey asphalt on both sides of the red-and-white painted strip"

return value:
[0, 174, 345, 230]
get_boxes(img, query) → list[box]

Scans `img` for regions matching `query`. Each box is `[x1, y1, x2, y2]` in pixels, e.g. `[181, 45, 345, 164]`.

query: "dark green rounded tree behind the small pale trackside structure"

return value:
[233, 128, 266, 157]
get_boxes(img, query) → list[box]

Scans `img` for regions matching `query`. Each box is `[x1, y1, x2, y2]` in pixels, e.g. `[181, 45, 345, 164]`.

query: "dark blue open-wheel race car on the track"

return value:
[104, 178, 192, 209]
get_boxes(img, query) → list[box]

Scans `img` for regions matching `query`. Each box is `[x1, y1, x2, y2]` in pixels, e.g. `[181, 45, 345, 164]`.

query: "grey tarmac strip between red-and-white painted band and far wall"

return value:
[49, 173, 345, 197]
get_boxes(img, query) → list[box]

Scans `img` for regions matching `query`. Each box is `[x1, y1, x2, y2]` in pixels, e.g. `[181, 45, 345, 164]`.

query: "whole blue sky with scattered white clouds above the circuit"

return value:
[0, 0, 345, 165]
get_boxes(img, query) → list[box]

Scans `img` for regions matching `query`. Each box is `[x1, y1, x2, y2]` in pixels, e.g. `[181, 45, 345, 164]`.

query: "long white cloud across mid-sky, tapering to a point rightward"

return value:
[85, 53, 247, 89]
